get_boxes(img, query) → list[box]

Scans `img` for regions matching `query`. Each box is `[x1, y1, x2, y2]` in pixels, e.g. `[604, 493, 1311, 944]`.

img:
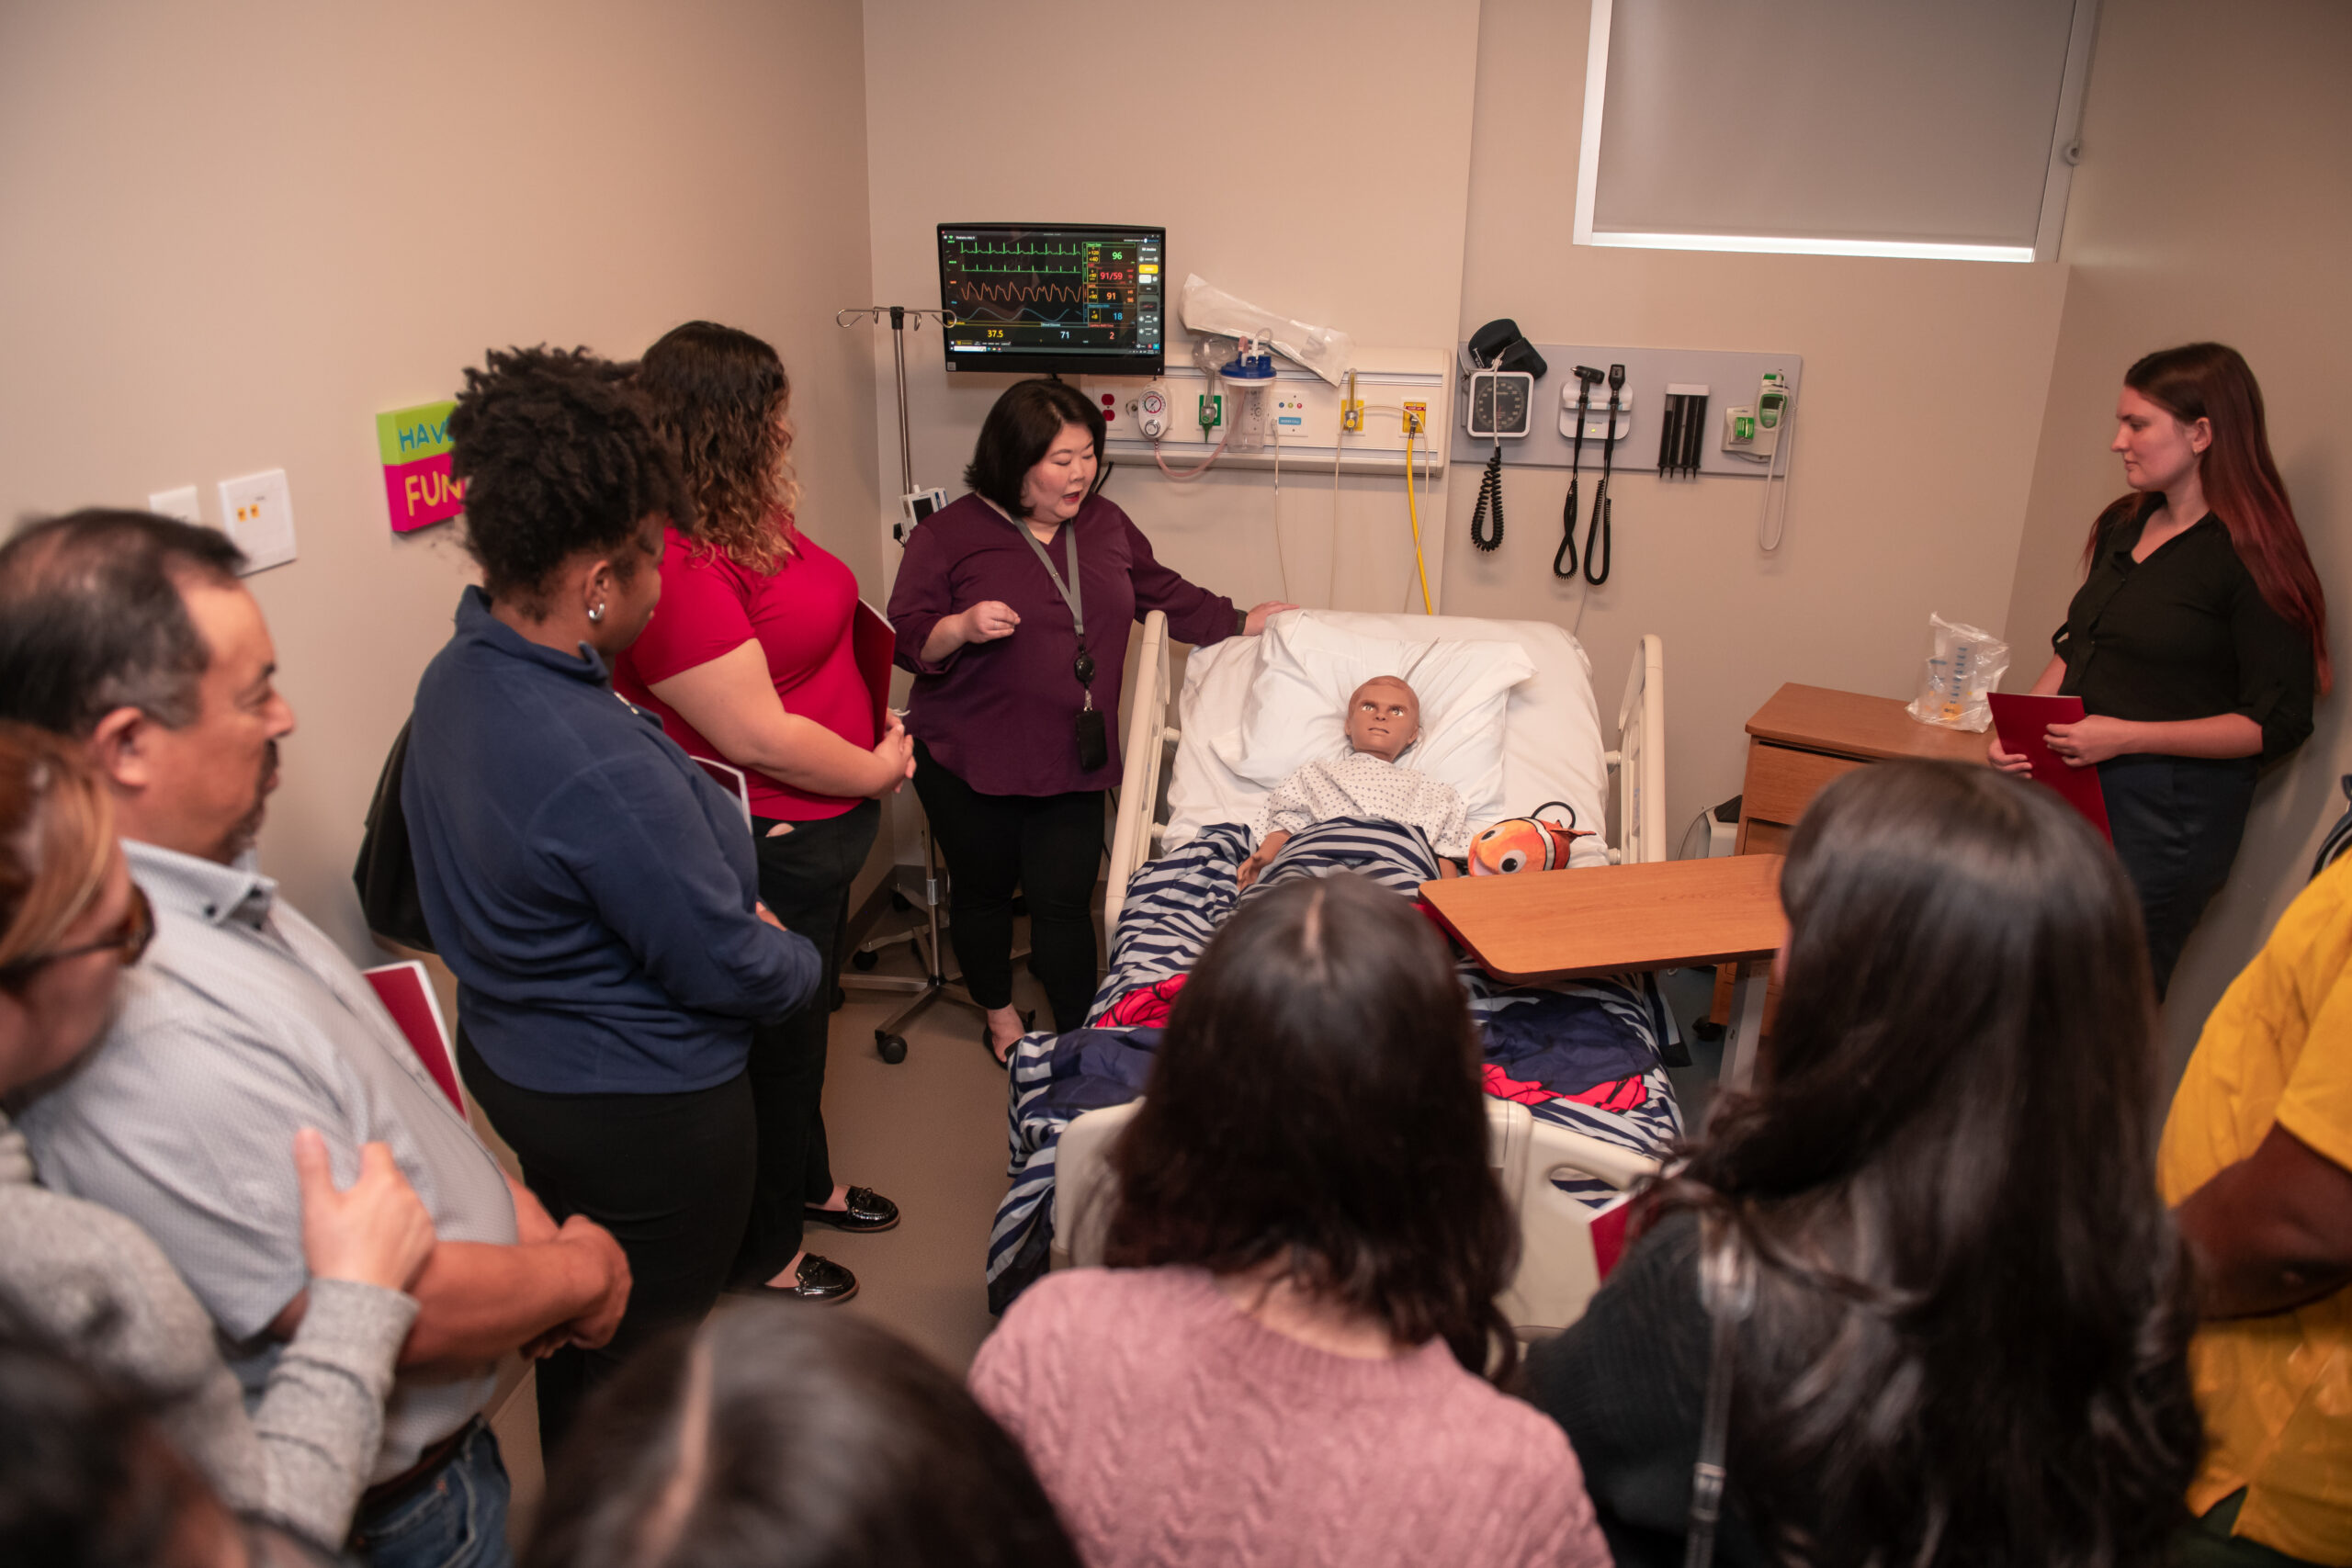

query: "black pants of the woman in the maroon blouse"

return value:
[915, 740, 1103, 1030]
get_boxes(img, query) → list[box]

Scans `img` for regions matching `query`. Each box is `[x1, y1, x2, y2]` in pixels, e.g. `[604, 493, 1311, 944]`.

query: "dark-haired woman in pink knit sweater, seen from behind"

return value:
[971, 874, 1609, 1568]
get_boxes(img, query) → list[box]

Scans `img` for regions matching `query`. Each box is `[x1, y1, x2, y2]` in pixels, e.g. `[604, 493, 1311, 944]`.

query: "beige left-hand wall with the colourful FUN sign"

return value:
[0, 0, 882, 954]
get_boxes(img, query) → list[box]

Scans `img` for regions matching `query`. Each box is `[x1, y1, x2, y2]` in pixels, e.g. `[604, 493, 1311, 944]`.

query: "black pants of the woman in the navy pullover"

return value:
[457, 1022, 755, 1455]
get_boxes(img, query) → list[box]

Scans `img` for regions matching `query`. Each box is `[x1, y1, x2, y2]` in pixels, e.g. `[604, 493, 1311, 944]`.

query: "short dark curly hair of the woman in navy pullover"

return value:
[449, 345, 694, 614]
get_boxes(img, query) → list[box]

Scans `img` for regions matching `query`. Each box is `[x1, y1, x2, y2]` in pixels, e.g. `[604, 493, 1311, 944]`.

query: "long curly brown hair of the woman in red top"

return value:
[638, 322, 799, 576]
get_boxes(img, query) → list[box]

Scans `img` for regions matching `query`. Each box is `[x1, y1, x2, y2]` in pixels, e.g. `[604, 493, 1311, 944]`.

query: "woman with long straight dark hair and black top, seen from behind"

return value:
[1529, 761, 2199, 1568]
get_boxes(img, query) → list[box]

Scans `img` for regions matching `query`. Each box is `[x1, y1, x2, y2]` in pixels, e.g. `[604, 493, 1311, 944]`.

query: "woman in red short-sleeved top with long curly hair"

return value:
[614, 322, 915, 1303]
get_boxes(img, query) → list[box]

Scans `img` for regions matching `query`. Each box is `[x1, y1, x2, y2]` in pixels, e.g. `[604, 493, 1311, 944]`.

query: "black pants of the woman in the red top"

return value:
[734, 799, 882, 1283]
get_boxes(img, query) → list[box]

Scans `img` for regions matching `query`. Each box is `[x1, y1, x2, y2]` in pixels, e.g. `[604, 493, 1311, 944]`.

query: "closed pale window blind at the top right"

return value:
[1576, 0, 2096, 261]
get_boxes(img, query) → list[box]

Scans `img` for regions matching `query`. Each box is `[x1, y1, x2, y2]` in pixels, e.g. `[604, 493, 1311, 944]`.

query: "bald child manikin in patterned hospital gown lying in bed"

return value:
[1239, 674, 1470, 888]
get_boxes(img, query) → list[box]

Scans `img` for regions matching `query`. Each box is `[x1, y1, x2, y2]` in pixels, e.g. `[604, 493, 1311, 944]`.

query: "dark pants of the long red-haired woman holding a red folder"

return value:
[2098, 755, 2256, 1001]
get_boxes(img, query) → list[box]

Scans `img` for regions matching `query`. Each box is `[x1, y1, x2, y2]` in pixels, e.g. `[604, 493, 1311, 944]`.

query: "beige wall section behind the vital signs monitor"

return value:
[865, 0, 1477, 609]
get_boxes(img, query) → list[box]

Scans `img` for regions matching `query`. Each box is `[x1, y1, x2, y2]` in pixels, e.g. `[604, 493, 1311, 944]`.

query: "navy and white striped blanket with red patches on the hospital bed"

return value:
[988, 818, 1681, 1312]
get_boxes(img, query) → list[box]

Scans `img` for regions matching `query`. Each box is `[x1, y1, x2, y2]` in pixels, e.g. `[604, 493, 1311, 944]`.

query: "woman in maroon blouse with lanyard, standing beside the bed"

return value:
[889, 381, 1291, 1060]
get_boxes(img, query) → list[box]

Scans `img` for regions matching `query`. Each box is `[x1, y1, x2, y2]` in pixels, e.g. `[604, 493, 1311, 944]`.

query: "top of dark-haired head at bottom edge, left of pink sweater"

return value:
[522, 1307, 1077, 1568]
